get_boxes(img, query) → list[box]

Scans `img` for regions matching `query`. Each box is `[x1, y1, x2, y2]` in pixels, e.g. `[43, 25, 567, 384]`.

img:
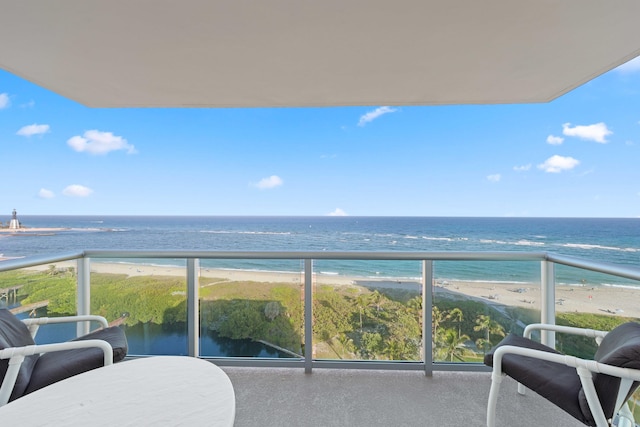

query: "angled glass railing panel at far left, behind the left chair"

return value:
[0, 261, 77, 344]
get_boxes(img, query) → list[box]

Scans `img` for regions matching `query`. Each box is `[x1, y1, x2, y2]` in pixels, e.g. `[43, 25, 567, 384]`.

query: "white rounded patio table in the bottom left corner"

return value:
[0, 356, 235, 427]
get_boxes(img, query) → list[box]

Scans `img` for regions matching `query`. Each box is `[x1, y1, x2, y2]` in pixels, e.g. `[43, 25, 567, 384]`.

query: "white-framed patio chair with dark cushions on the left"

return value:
[0, 308, 127, 406]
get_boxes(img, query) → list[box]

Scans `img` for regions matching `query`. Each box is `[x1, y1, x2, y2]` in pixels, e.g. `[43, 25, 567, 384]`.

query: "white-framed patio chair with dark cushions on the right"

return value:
[484, 322, 640, 427]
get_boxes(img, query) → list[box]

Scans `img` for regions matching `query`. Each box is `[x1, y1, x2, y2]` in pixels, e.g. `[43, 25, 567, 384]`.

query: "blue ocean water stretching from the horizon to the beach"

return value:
[0, 216, 640, 286]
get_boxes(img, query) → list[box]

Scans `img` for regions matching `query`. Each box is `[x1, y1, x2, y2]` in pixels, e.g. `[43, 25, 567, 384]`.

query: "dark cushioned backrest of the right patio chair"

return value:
[579, 322, 640, 419]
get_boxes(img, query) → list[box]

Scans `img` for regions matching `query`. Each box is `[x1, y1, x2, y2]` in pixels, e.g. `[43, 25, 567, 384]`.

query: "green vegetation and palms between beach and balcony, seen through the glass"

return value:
[0, 265, 630, 362]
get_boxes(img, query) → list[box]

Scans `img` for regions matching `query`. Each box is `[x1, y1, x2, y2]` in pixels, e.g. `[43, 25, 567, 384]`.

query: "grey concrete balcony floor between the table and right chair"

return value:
[222, 367, 583, 427]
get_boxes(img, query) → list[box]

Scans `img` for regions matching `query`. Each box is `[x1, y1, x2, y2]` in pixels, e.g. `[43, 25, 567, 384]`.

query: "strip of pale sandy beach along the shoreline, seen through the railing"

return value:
[22, 261, 640, 318]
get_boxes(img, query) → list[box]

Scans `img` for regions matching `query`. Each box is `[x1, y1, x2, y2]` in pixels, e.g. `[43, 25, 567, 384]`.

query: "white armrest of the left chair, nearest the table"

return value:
[0, 340, 113, 407]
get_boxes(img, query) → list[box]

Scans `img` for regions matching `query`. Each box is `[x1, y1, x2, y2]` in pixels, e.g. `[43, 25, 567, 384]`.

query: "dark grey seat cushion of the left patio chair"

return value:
[24, 326, 127, 394]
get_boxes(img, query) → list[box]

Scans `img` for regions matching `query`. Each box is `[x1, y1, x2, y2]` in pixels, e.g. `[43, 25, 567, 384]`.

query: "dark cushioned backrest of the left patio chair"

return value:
[0, 308, 38, 400]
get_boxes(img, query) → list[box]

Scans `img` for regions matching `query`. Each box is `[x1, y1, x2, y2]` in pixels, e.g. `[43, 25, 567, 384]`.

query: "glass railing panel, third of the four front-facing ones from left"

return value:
[313, 260, 422, 361]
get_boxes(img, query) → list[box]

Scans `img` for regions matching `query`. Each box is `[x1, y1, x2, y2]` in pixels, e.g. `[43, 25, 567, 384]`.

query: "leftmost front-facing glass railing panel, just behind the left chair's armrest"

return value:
[91, 258, 188, 355]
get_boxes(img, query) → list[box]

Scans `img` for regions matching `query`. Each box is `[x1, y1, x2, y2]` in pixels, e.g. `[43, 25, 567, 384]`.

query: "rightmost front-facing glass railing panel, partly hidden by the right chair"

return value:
[431, 261, 541, 363]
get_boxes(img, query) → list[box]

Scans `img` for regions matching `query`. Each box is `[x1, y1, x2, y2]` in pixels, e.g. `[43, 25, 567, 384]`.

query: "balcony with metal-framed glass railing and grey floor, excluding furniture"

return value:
[0, 250, 640, 426]
